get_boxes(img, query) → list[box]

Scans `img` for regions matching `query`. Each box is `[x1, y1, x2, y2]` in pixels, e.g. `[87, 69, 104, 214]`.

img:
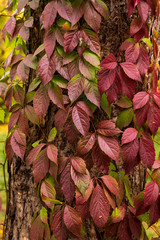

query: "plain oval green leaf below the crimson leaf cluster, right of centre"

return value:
[116, 108, 134, 129]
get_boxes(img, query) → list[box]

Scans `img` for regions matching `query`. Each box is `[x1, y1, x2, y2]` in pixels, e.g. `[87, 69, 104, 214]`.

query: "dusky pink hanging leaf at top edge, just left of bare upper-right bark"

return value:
[84, 2, 101, 32]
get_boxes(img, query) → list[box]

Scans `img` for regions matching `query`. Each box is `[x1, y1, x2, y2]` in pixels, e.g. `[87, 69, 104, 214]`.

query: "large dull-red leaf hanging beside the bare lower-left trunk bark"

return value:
[33, 148, 49, 184]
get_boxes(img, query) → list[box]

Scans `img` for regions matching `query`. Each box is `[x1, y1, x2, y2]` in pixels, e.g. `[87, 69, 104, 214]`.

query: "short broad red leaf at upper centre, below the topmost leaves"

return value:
[64, 31, 79, 53]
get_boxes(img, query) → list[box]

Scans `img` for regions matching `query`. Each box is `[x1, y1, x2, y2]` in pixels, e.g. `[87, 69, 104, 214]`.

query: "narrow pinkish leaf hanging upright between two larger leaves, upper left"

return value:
[44, 30, 56, 59]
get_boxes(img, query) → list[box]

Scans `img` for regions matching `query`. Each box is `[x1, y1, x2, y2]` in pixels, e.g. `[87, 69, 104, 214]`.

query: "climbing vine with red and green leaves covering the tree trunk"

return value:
[0, 0, 160, 240]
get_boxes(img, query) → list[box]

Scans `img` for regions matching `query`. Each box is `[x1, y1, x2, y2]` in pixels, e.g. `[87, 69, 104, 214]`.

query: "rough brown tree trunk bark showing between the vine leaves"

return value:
[5, 0, 144, 240]
